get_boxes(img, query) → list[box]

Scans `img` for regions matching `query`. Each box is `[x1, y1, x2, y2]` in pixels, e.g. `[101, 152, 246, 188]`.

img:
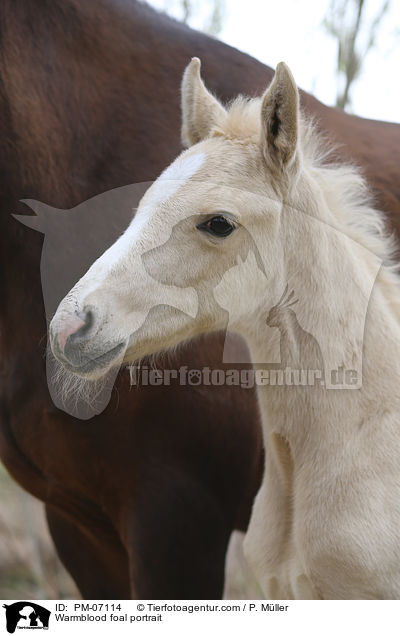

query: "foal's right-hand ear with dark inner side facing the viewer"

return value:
[261, 62, 299, 169]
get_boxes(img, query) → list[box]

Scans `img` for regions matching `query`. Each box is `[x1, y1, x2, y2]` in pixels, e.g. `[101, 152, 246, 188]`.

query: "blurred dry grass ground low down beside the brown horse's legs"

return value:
[0, 464, 260, 600]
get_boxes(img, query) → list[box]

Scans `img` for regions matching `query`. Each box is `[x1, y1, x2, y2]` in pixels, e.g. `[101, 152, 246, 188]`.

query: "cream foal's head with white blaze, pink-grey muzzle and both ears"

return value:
[51, 58, 302, 378]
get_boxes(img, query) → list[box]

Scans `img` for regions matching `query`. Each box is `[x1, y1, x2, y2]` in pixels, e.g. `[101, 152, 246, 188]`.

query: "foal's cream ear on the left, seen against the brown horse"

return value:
[181, 57, 226, 147]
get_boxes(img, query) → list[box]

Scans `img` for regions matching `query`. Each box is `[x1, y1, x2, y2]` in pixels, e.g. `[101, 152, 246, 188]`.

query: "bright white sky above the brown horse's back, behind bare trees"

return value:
[148, 0, 400, 123]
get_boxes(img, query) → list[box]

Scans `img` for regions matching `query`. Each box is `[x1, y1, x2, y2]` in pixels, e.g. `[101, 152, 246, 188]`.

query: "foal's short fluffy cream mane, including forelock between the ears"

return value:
[212, 95, 400, 310]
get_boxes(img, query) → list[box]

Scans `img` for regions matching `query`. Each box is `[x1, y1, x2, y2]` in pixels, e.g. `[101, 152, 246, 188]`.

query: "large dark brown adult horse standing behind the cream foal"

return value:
[0, 0, 400, 598]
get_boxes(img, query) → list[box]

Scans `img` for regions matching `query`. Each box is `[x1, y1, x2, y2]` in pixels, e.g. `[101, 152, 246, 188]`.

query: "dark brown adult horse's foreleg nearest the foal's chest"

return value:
[126, 467, 232, 599]
